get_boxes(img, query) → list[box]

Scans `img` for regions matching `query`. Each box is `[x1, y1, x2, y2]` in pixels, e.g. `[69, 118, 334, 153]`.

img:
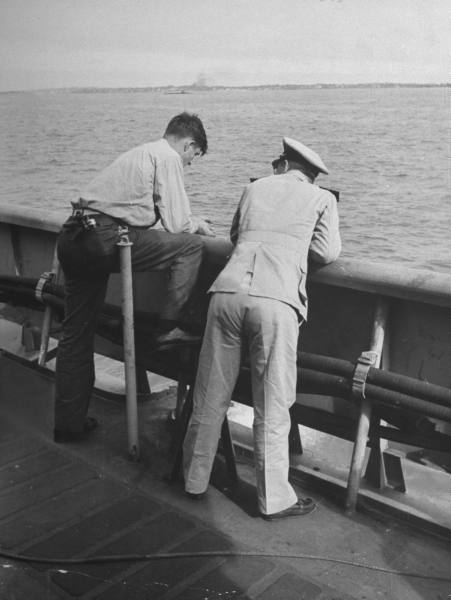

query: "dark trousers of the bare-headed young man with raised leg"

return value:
[55, 215, 204, 432]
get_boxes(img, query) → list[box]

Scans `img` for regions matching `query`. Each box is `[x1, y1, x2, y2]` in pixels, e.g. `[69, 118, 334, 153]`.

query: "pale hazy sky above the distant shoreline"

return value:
[0, 0, 451, 91]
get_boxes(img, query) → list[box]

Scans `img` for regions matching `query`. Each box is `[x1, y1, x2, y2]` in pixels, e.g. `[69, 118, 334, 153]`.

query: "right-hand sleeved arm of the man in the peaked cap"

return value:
[309, 192, 341, 265]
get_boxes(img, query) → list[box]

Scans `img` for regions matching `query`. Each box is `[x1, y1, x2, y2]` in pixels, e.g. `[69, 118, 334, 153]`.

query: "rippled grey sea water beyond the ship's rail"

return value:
[0, 87, 451, 273]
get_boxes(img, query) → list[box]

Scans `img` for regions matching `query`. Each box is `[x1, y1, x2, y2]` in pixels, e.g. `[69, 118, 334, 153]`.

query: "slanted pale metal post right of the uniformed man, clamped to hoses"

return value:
[345, 298, 389, 514]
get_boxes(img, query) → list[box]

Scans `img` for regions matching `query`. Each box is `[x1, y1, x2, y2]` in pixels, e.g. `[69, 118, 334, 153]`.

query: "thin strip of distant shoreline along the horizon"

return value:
[0, 82, 451, 94]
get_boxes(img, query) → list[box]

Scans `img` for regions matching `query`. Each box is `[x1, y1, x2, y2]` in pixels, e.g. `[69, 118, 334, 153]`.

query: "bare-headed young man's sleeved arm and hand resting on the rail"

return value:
[153, 157, 214, 236]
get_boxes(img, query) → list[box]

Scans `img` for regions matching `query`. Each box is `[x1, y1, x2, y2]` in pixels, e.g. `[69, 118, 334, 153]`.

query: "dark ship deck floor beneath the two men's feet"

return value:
[0, 352, 451, 600]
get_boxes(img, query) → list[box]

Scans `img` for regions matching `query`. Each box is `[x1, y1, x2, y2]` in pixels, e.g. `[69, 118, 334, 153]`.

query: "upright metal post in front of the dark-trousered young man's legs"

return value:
[117, 227, 139, 461]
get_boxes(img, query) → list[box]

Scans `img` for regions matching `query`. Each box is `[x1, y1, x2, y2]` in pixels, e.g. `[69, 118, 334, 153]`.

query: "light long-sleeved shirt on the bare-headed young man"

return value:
[80, 138, 198, 233]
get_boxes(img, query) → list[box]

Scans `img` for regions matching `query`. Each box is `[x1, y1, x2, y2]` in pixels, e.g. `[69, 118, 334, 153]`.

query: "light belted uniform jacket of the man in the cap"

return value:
[209, 170, 341, 319]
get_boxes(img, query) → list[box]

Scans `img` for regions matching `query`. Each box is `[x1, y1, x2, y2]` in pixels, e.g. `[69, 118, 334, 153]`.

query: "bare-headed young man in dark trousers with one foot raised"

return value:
[54, 113, 214, 442]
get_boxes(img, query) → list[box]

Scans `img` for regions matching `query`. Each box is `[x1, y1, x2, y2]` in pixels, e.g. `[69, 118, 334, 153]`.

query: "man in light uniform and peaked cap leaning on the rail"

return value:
[184, 138, 341, 520]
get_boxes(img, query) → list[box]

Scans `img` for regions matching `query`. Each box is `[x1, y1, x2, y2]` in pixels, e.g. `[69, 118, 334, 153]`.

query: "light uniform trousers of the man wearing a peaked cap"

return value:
[184, 291, 299, 514]
